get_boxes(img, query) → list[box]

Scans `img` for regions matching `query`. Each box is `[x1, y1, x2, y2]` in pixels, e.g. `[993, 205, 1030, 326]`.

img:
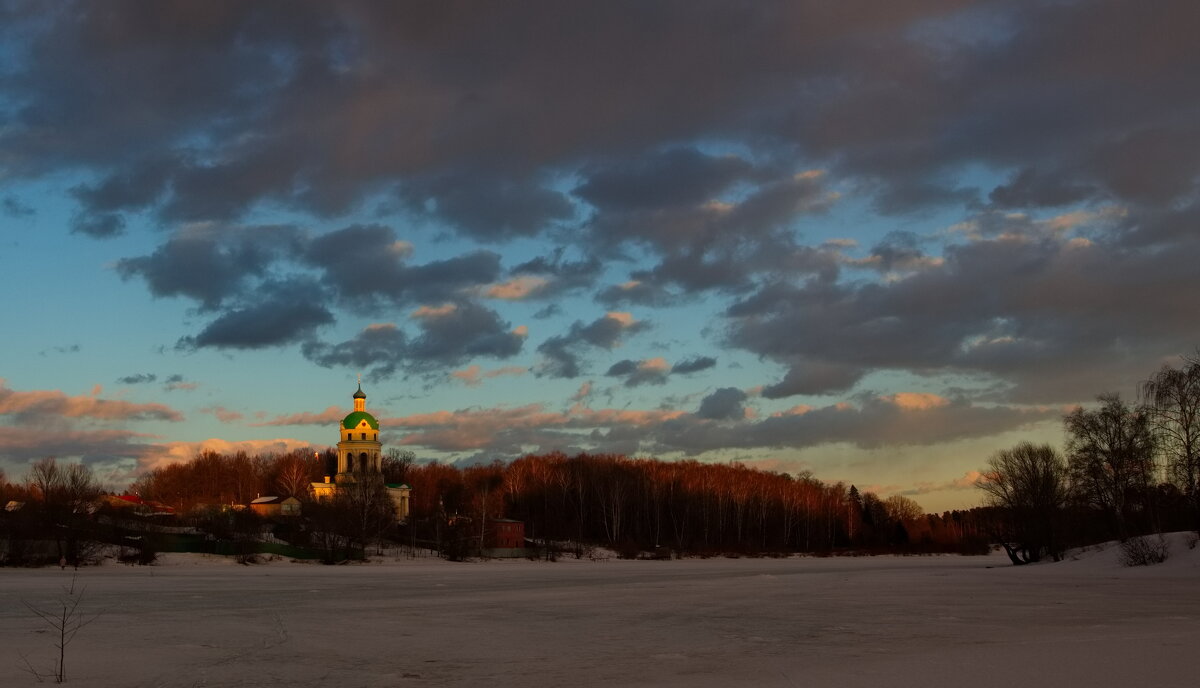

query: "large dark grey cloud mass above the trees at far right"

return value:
[728, 226, 1200, 402]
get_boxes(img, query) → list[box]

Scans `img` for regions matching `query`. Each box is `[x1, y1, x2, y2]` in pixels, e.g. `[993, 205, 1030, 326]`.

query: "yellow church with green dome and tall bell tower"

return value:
[312, 382, 413, 522]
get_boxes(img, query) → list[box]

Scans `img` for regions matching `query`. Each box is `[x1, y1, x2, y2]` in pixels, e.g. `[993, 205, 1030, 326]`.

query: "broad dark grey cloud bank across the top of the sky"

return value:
[0, 0, 1200, 232]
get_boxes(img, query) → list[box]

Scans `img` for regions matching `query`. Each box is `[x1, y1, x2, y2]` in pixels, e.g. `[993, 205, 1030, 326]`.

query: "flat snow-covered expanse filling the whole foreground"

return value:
[0, 534, 1200, 688]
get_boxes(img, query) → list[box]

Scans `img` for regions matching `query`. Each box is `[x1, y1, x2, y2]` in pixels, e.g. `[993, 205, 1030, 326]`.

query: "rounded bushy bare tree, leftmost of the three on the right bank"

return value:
[976, 442, 1070, 564]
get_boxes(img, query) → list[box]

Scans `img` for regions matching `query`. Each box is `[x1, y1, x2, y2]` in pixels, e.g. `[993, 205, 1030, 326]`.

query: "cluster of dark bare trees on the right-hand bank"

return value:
[978, 357, 1200, 564]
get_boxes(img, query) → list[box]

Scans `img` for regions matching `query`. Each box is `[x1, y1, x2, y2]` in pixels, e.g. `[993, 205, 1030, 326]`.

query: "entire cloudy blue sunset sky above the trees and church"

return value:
[0, 0, 1200, 510]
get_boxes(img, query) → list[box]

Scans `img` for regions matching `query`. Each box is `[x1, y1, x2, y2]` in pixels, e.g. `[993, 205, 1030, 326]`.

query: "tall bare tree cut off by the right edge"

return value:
[1140, 355, 1200, 532]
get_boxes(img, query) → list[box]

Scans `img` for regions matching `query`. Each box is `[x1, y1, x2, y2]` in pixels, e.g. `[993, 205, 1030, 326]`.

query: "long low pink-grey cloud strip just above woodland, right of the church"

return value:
[369, 388, 1061, 457]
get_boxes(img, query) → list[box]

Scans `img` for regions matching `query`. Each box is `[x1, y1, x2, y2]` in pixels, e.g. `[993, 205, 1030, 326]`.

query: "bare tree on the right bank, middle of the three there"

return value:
[1063, 394, 1154, 540]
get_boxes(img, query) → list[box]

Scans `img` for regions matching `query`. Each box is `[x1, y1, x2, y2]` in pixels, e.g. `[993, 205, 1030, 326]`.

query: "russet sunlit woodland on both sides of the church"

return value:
[124, 450, 994, 552]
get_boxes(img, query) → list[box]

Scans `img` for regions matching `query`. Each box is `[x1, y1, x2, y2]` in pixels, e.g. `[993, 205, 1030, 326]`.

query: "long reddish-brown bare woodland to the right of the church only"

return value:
[409, 454, 985, 552]
